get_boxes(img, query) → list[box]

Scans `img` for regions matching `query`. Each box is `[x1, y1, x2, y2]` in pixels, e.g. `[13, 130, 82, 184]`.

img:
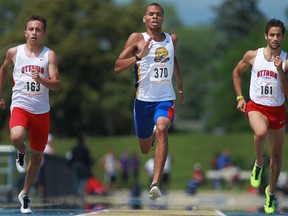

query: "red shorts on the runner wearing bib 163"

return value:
[9, 107, 50, 152]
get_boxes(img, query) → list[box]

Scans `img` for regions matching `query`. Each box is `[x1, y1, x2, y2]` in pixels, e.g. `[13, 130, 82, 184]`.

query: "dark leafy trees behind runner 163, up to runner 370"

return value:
[0, 0, 184, 136]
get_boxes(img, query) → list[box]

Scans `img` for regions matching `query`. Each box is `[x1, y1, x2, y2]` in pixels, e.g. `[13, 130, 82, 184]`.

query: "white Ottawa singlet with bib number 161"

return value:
[250, 47, 287, 106]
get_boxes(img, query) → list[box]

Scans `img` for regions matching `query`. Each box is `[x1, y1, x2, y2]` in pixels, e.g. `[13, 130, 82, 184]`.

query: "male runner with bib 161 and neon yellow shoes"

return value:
[233, 19, 288, 214]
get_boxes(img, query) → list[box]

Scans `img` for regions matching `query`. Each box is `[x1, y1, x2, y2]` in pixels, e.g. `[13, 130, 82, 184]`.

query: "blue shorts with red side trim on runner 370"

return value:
[134, 99, 175, 139]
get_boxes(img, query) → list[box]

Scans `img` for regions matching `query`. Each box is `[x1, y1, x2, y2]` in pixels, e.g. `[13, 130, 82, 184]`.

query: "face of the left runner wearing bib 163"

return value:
[24, 20, 45, 44]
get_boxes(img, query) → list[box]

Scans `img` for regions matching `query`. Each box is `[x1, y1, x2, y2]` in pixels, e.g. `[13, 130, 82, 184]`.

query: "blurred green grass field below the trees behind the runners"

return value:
[46, 133, 288, 190]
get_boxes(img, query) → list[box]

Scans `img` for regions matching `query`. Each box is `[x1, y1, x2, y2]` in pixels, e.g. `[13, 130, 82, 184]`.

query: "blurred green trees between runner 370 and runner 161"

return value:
[166, 0, 263, 133]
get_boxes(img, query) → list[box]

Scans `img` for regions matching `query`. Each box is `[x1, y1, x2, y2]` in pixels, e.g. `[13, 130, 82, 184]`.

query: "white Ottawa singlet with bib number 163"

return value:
[11, 44, 50, 114]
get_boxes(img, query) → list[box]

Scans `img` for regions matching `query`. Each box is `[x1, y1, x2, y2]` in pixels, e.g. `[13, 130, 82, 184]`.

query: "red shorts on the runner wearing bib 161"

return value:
[246, 101, 286, 130]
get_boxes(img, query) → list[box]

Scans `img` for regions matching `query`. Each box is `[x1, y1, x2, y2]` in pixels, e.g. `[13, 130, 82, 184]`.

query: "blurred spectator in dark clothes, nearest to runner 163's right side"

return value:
[66, 134, 93, 194]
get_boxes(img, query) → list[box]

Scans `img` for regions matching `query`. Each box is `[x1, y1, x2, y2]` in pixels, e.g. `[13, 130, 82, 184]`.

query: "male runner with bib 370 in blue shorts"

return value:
[115, 3, 184, 200]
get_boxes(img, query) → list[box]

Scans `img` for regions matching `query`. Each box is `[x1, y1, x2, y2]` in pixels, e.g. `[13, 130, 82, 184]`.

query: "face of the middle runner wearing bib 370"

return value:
[143, 5, 164, 30]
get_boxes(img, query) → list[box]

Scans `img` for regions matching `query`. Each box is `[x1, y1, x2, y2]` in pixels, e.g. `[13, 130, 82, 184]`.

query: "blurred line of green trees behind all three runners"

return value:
[0, 0, 287, 139]
